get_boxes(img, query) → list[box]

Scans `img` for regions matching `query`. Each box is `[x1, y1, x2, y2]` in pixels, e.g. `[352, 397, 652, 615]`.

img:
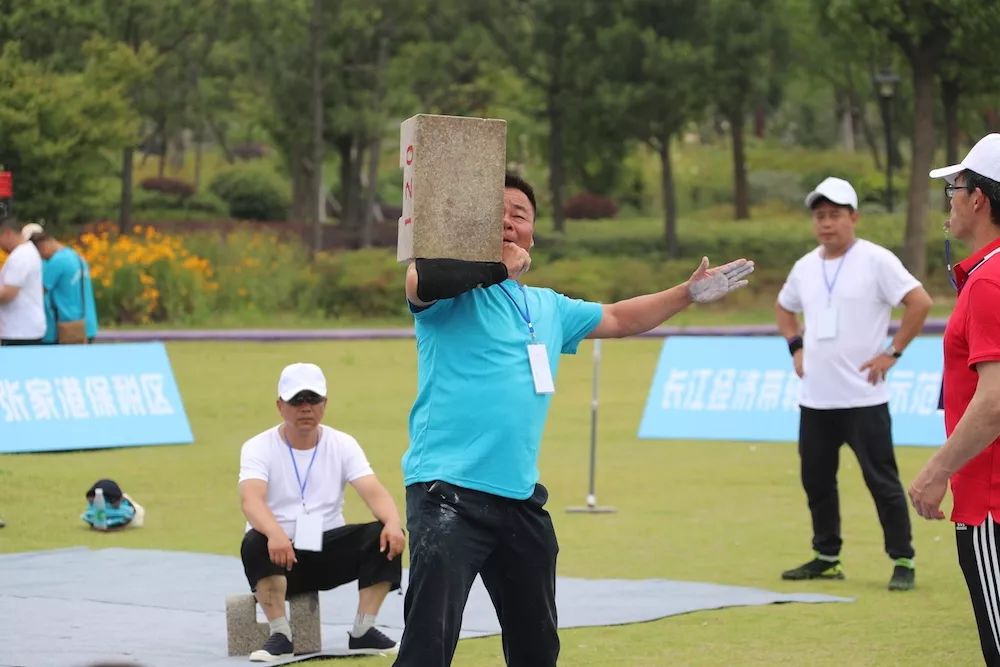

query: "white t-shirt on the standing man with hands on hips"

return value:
[778, 239, 920, 409]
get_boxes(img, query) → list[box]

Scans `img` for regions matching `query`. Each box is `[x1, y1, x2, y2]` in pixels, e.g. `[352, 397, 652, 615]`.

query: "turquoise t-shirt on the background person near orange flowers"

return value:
[42, 248, 97, 343]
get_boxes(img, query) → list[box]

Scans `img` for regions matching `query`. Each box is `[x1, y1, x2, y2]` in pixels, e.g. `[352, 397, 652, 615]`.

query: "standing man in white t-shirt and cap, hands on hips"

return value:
[775, 178, 931, 590]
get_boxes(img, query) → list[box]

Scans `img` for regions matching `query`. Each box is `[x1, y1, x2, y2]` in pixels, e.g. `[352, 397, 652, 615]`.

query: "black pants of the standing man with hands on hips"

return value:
[799, 403, 913, 558]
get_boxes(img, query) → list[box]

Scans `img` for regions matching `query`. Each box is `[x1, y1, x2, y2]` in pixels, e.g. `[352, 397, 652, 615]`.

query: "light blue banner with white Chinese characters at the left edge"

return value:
[0, 343, 194, 453]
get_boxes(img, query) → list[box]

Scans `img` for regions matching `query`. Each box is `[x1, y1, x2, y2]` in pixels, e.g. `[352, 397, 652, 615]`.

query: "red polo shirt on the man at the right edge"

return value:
[944, 239, 1000, 526]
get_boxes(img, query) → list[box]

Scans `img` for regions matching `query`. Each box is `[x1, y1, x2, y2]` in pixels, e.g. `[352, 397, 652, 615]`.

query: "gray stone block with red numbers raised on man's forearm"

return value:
[396, 114, 507, 262]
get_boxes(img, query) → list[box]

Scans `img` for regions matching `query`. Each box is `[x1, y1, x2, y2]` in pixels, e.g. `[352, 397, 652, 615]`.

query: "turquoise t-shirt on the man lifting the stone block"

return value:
[403, 280, 602, 500]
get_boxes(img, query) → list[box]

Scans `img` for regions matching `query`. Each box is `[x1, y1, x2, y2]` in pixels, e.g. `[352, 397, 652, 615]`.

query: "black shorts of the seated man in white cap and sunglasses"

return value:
[240, 521, 403, 596]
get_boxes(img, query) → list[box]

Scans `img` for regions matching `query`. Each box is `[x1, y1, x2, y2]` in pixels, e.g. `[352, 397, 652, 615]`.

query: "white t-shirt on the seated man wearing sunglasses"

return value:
[239, 425, 374, 539]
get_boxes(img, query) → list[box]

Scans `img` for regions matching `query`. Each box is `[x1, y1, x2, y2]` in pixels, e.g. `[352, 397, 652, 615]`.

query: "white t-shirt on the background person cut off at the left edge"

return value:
[0, 242, 45, 340]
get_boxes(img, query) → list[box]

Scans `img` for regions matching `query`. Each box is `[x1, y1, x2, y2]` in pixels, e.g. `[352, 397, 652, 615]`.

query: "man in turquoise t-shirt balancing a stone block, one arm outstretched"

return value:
[395, 174, 753, 667]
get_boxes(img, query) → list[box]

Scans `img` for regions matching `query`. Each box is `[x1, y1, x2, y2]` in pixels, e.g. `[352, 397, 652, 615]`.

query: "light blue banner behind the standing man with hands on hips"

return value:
[639, 336, 944, 446]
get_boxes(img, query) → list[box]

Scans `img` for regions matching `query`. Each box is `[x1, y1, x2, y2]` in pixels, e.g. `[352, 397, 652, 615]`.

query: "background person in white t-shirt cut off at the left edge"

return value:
[0, 218, 45, 345]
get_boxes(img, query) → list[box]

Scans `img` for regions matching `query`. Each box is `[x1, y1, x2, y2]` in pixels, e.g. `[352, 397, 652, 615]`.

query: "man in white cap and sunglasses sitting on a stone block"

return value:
[239, 363, 405, 662]
